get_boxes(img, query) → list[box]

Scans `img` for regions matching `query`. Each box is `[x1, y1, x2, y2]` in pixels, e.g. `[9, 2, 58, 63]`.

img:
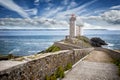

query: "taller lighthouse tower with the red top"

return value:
[69, 14, 76, 38]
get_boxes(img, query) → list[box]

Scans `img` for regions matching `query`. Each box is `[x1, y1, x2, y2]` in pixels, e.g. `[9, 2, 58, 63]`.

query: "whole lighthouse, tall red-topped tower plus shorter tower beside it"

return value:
[69, 14, 83, 38]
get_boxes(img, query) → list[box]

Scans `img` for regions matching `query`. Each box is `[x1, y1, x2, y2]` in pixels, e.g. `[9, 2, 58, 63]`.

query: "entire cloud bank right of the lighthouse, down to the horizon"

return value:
[80, 10, 120, 30]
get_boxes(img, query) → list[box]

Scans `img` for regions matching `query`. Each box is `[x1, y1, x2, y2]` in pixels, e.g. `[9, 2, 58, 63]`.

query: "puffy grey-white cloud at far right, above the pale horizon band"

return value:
[82, 10, 120, 25]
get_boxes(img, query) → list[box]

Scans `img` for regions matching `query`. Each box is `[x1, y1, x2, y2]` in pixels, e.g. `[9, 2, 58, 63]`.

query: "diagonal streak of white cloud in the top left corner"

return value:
[0, 0, 29, 18]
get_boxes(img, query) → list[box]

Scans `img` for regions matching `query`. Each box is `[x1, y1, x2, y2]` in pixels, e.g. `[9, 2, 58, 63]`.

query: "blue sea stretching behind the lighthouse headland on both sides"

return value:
[0, 29, 120, 56]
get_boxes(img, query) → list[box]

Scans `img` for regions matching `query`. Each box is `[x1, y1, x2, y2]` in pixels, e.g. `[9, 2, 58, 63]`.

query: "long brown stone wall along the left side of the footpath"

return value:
[0, 48, 94, 80]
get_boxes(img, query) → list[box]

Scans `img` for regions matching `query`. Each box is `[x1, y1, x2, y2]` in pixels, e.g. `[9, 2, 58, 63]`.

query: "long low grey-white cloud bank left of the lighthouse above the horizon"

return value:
[0, 17, 68, 29]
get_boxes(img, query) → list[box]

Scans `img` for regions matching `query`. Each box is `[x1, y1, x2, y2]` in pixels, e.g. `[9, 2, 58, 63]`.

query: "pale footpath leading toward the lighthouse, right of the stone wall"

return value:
[62, 48, 120, 80]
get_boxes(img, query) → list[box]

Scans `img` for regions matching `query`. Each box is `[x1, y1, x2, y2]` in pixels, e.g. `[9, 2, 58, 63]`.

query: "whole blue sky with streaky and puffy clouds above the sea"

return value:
[0, 0, 120, 30]
